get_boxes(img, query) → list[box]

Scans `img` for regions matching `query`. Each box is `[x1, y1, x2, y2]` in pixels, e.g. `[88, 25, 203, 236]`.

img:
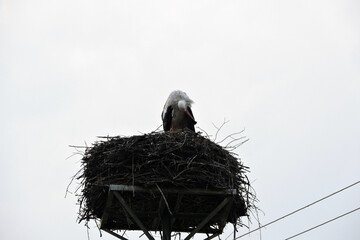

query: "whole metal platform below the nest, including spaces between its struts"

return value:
[100, 185, 238, 240]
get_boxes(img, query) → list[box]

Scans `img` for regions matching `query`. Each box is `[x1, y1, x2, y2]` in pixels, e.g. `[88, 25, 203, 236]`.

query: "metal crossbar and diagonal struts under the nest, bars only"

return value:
[100, 185, 238, 240]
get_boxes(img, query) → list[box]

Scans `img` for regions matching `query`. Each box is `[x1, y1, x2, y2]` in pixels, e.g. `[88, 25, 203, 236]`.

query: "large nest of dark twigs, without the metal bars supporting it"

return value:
[78, 131, 254, 231]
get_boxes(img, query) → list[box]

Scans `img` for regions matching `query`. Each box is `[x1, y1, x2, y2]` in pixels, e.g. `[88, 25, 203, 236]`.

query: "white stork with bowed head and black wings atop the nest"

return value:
[161, 90, 196, 132]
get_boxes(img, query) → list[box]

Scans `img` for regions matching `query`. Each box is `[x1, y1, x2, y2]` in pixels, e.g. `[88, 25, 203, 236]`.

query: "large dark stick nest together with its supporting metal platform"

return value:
[78, 131, 251, 239]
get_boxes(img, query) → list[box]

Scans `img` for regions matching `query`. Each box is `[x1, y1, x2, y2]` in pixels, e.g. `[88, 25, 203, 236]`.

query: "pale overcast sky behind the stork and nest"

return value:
[0, 0, 360, 240]
